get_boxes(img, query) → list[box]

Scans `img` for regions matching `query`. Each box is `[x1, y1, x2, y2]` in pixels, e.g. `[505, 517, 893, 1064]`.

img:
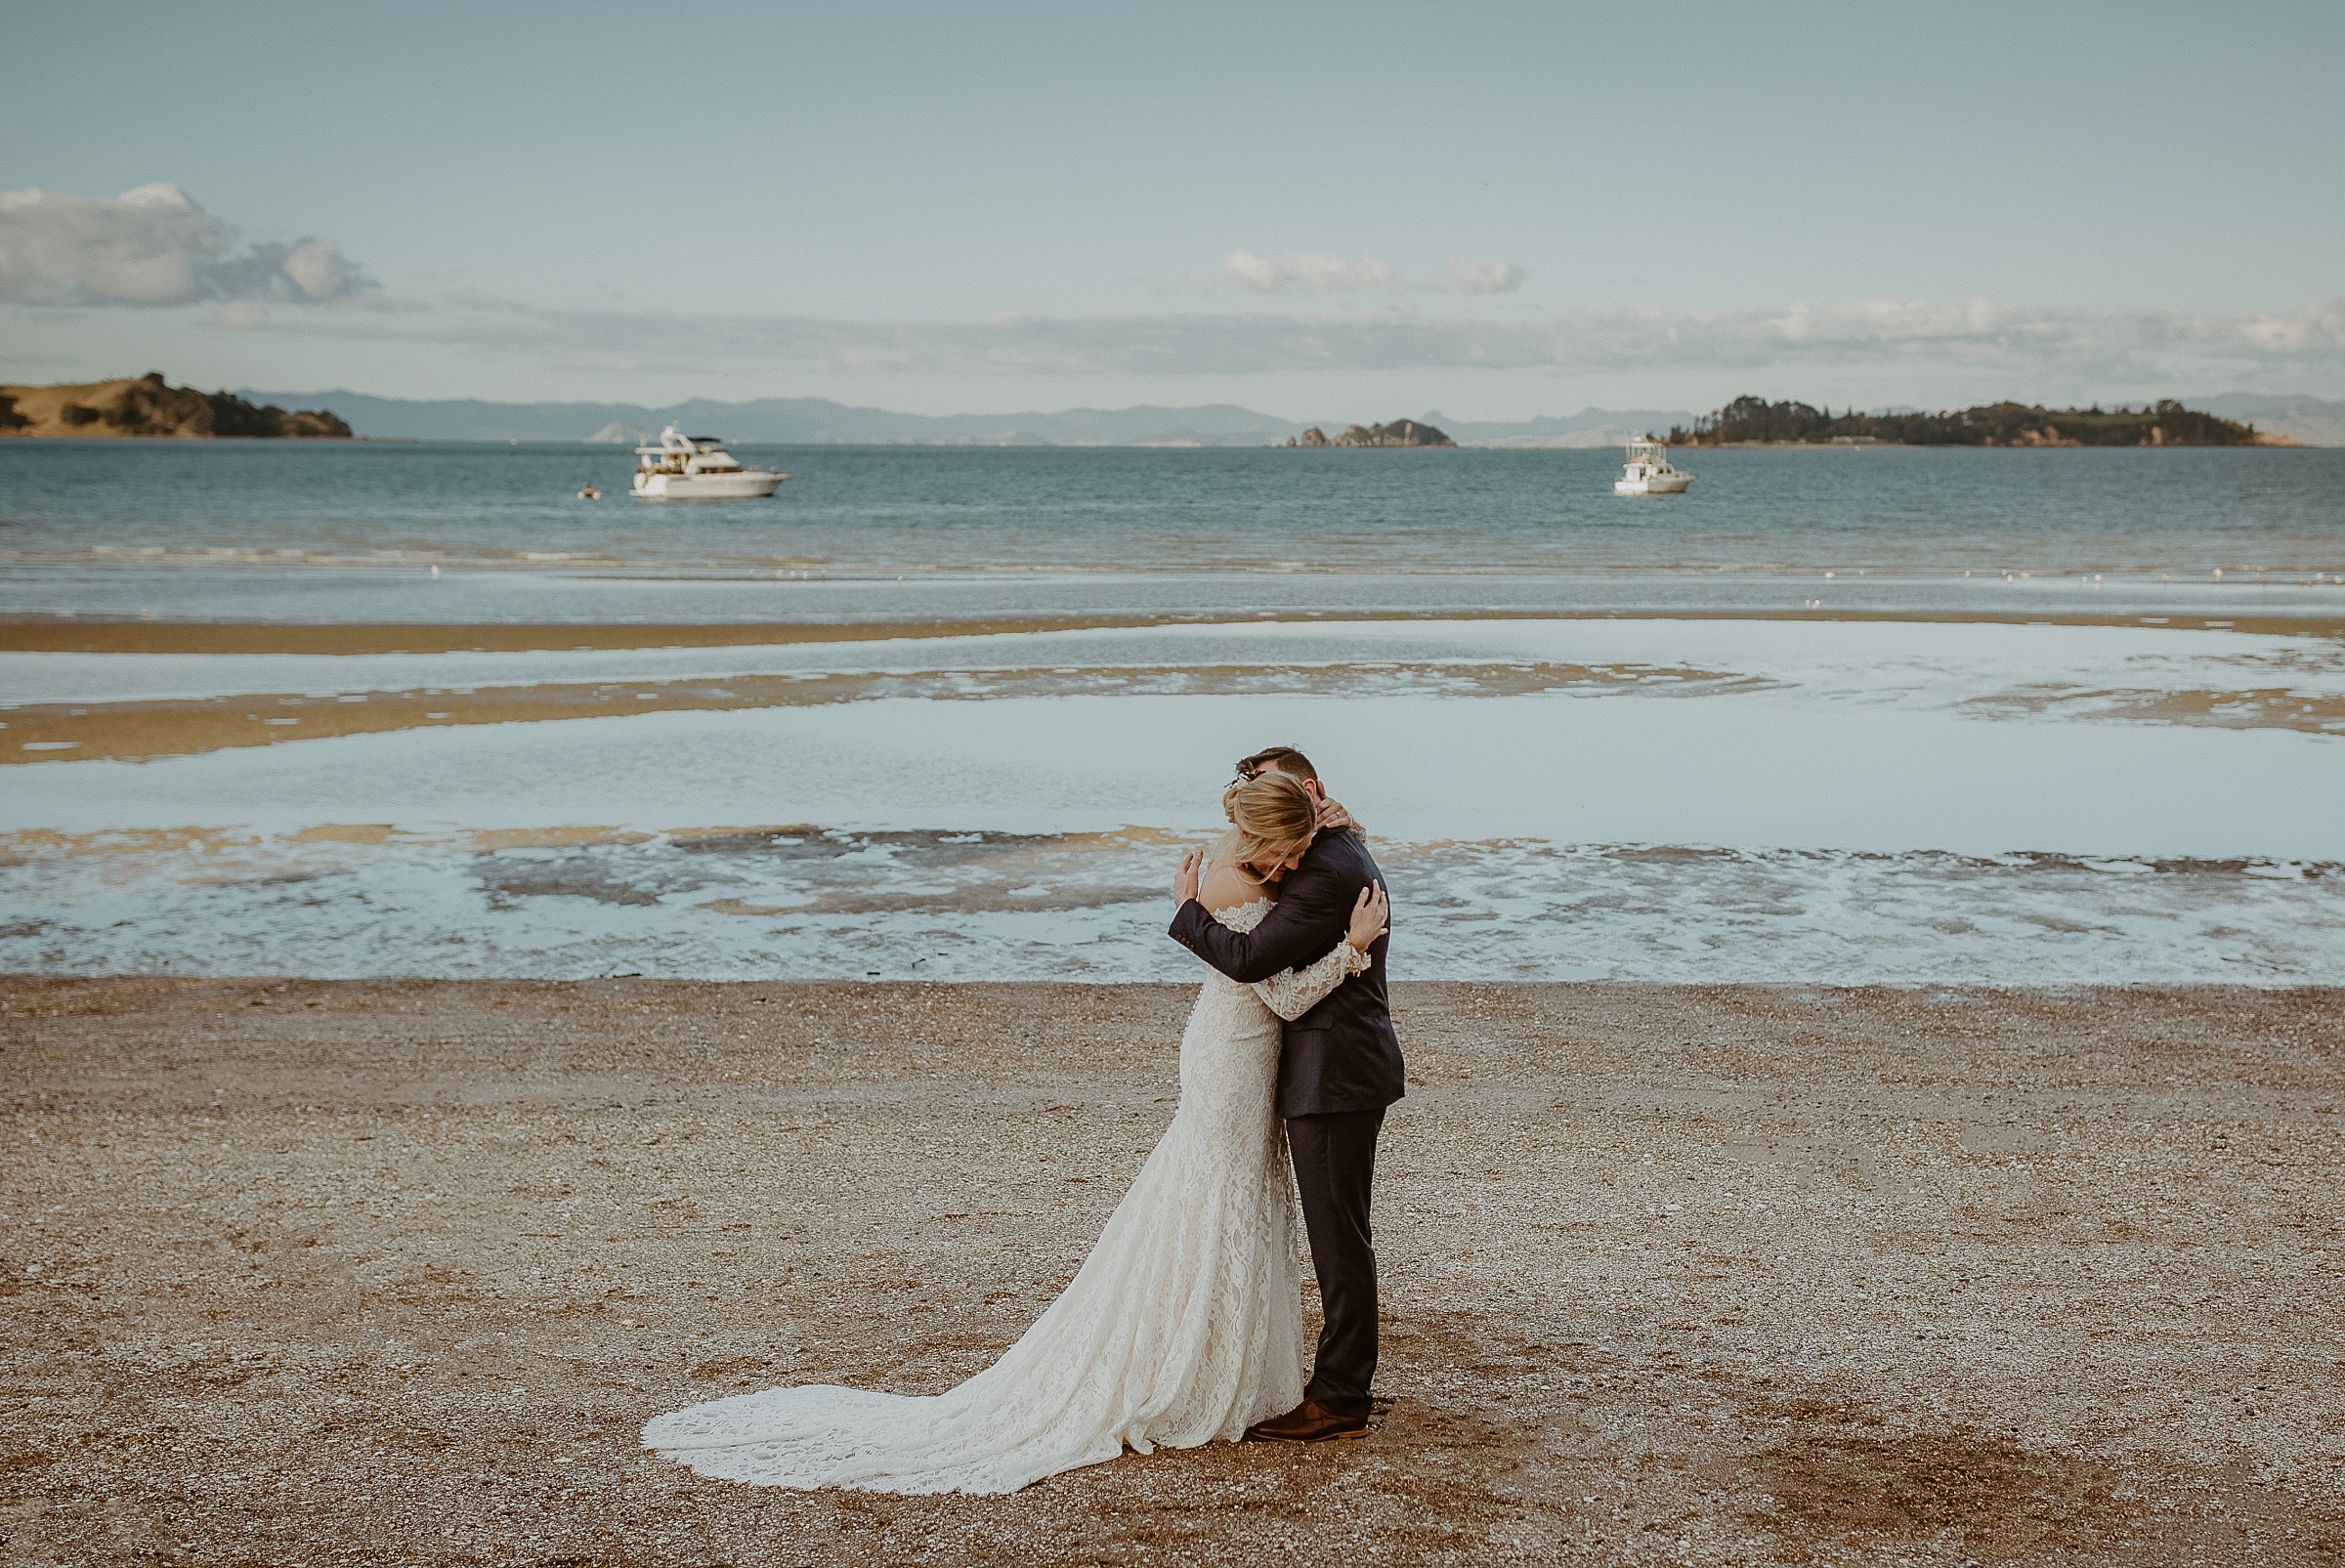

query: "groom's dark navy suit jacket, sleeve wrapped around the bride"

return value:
[1172, 829, 1409, 1116]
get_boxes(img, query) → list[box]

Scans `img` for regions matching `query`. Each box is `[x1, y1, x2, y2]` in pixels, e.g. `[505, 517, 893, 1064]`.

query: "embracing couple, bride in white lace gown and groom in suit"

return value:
[643, 745, 1405, 1493]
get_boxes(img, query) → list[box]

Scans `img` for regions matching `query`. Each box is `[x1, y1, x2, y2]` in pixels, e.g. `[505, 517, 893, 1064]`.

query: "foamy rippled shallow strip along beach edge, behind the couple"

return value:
[0, 827, 2345, 985]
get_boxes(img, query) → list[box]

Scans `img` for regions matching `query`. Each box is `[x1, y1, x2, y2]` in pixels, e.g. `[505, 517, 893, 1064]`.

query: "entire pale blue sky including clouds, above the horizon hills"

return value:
[0, 2, 2345, 417]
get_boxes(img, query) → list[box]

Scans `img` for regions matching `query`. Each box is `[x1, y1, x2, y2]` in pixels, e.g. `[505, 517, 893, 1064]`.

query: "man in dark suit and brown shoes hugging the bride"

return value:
[1172, 745, 1407, 1444]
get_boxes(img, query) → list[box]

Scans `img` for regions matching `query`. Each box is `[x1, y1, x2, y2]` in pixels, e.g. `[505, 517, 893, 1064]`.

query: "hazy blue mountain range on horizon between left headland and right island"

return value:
[241, 392, 1693, 445]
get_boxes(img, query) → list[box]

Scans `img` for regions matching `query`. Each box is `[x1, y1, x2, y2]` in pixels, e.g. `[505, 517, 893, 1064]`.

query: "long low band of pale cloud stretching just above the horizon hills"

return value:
[312, 295, 2345, 387]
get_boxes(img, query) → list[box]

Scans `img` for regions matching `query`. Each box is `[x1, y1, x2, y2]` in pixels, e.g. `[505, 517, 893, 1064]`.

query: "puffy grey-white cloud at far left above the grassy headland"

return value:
[0, 186, 373, 305]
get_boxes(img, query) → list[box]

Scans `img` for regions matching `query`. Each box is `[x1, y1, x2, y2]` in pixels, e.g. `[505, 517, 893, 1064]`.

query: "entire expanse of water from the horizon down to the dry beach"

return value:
[0, 443, 2345, 985]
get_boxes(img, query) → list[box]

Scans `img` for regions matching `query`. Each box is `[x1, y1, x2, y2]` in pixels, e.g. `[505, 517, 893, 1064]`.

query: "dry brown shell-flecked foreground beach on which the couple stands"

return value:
[0, 980, 2345, 1566]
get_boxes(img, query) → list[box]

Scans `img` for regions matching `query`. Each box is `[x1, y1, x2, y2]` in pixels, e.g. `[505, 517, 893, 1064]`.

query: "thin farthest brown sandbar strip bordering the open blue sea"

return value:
[0, 595, 2345, 654]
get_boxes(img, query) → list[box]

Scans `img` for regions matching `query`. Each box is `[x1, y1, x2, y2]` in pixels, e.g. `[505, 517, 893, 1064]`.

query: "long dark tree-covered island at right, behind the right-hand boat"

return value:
[1667, 399, 2298, 445]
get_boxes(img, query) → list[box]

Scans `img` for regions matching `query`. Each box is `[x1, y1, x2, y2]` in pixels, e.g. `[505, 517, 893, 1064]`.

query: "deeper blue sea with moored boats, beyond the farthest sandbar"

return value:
[0, 441, 2345, 621]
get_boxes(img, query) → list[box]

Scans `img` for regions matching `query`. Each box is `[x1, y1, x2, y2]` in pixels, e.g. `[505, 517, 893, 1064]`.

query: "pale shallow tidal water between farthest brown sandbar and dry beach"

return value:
[0, 621, 2345, 985]
